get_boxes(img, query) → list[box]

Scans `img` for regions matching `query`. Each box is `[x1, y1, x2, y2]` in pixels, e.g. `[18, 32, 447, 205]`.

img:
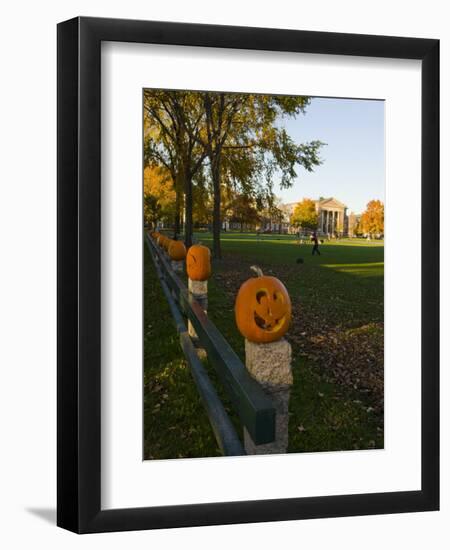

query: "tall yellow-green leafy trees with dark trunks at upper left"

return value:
[144, 90, 323, 257]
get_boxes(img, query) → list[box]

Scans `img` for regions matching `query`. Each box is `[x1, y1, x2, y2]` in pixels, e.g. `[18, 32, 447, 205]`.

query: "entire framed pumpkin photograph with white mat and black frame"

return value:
[57, 17, 439, 533]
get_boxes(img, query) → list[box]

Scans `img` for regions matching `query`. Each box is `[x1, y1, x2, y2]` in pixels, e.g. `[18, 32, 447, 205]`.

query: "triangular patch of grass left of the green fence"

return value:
[144, 244, 220, 459]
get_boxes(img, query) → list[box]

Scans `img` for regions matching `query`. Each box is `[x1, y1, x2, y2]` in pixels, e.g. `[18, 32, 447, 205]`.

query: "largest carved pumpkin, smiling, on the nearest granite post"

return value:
[234, 266, 292, 343]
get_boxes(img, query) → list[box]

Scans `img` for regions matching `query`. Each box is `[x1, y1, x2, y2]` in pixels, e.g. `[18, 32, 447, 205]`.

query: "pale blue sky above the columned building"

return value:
[275, 98, 385, 214]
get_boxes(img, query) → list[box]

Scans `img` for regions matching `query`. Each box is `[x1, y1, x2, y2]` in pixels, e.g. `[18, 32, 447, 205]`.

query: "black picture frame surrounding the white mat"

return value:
[57, 17, 439, 533]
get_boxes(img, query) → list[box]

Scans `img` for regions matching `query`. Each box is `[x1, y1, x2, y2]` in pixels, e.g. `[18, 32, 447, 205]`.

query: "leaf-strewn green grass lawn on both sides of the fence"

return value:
[144, 233, 384, 458]
